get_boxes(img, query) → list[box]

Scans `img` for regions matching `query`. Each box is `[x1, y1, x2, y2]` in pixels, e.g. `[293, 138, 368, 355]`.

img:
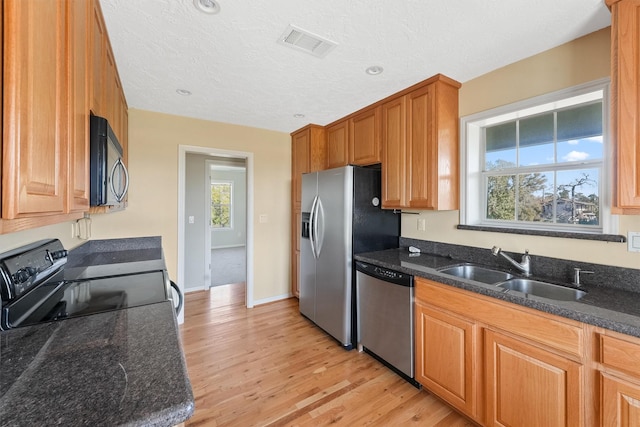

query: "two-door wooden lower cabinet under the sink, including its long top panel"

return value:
[415, 278, 596, 427]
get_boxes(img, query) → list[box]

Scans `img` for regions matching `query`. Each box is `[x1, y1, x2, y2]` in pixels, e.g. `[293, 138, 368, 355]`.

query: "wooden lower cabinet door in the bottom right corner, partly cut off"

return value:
[600, 373, 640, 427]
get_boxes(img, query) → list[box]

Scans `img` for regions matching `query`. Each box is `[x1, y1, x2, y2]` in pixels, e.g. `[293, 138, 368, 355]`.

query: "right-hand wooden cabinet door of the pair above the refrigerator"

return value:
[349, 107, 381, 166]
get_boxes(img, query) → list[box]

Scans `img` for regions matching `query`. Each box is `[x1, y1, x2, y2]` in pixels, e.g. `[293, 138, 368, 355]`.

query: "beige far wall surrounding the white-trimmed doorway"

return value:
[87, 109, 291, 302]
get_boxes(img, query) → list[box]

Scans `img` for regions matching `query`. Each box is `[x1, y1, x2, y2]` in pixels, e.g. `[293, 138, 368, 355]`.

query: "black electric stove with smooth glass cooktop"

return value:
[0, 239, 180, 330]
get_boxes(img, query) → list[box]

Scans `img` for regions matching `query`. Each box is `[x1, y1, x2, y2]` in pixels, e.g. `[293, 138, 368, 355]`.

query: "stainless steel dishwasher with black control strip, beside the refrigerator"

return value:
[356, 261, 419, 387]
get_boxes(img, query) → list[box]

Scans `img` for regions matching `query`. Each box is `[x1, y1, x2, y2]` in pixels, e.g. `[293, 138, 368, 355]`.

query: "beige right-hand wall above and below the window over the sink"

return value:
[402, 28, 640, 268]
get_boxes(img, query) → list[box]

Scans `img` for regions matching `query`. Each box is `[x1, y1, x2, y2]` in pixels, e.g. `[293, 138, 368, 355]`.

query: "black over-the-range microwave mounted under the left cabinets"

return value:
[89, 115, 129, 206]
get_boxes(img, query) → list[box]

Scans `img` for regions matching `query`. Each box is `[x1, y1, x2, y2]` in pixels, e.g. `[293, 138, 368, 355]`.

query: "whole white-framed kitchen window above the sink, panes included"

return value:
[460, 80, 615, 234]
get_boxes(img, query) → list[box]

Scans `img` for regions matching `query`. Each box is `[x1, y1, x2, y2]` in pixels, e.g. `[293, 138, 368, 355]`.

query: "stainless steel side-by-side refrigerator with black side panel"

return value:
[299, 166, 400, 349]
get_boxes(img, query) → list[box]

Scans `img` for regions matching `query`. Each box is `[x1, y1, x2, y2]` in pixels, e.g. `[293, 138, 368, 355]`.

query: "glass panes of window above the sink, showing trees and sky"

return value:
[482, 100, 604, 231]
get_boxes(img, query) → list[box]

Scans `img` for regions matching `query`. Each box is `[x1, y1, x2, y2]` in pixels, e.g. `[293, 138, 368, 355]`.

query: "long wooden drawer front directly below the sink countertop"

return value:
[416, 278, 584, 359]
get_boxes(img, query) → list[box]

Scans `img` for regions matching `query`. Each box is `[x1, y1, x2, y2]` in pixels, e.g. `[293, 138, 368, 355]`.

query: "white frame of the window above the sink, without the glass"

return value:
[460, 78, 618, 235]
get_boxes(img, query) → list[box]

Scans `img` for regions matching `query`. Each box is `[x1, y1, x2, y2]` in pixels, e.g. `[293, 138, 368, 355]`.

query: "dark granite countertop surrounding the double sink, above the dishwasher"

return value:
[355, 248, 640, 338]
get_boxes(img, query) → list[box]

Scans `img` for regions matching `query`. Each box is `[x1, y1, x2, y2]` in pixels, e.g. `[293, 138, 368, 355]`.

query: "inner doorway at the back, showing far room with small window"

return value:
[204, 157, 247, 288]
